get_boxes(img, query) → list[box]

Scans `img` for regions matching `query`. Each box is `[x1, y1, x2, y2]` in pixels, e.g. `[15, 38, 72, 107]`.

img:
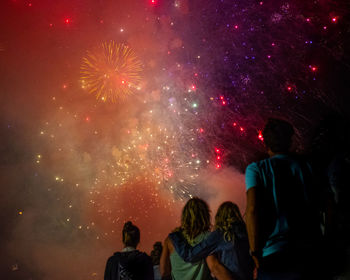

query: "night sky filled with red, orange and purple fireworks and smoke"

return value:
[0, 0, 350, 280]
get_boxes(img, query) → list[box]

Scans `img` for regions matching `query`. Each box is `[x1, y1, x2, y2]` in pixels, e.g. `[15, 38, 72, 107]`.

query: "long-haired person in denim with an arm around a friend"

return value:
[169, 201, 254, 280]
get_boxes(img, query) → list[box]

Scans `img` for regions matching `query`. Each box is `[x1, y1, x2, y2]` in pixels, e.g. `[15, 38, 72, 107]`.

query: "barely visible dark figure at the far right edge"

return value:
[311, 113, 350, 280]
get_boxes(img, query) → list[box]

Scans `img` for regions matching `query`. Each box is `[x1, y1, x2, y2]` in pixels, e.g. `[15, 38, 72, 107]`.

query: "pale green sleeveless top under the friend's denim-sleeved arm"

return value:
[170, 232, 212, 280]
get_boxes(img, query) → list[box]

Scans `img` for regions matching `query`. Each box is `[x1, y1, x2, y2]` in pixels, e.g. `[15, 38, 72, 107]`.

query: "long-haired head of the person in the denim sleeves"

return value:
[215, 201, 244, 241]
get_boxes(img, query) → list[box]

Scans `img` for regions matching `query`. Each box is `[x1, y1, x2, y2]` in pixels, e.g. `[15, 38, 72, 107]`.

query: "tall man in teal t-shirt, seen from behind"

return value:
[246, 119, 322, 279]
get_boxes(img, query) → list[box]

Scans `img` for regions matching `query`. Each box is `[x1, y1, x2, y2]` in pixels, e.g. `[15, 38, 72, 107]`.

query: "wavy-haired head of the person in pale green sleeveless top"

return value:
[181, 197, 210, 240]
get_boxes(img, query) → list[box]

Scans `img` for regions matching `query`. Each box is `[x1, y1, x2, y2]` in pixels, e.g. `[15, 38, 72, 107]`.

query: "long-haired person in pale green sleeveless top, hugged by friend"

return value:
[160, 197, 211, 280]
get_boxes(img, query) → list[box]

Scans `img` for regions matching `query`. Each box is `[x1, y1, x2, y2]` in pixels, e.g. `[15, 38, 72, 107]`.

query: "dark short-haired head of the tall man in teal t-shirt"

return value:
[263, 118, 294, 153]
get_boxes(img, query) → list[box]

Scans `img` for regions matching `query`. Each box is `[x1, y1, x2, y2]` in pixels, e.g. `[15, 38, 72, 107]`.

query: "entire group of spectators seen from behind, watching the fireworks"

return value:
[104, 118, 350, 280]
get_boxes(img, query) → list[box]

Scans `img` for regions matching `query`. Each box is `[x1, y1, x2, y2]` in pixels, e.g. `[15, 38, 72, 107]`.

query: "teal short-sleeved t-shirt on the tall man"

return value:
[245, 154, 320, 257]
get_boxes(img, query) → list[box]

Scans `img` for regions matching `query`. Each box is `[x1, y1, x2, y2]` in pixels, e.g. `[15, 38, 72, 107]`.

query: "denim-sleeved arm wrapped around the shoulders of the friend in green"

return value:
[169, 231, 221, 262]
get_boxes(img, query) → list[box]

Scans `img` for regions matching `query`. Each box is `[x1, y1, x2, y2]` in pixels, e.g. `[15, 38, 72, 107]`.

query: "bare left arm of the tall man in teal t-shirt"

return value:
[246, 187, 262, 267]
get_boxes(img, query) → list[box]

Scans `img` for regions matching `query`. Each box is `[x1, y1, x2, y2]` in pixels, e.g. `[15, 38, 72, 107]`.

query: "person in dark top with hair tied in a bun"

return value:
[104, 222, 153, 280]
